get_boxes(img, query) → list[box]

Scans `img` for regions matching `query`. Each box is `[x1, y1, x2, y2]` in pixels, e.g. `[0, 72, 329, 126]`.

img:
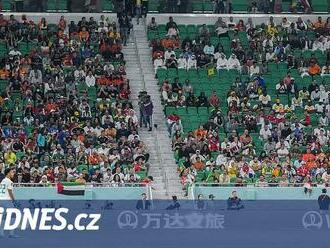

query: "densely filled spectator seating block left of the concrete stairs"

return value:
[0, 15, 149, 186]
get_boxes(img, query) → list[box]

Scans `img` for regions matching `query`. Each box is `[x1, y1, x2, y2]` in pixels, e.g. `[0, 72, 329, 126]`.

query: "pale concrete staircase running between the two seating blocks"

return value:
[123, 20, 184, 199]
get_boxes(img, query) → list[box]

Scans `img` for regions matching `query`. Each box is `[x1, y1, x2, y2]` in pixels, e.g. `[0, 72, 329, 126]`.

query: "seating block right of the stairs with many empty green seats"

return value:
[148, 15, 330, 190]
